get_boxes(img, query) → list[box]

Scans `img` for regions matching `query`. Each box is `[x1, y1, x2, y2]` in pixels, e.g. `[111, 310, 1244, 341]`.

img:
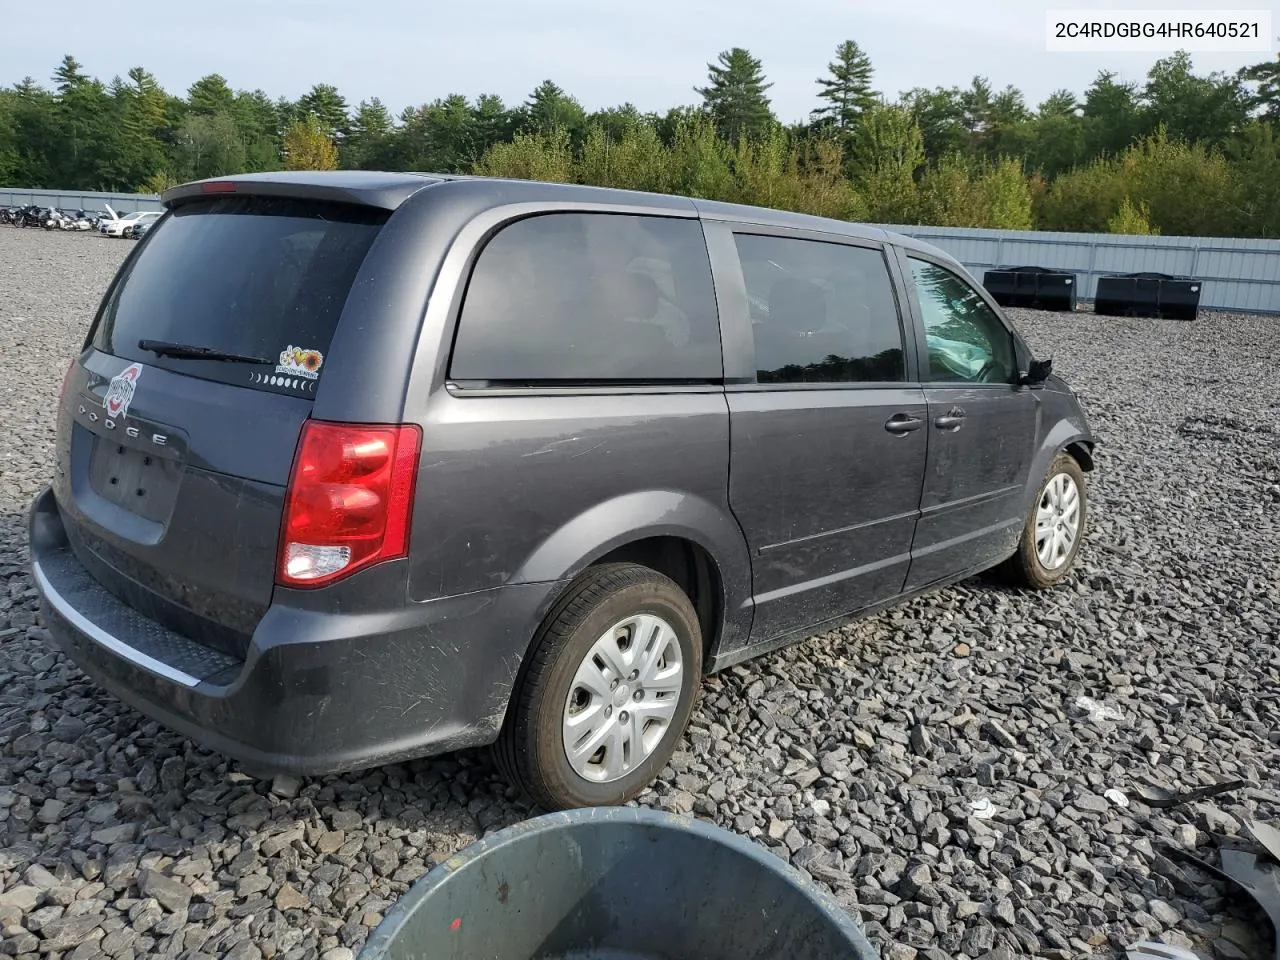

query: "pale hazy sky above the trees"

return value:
[10, 0, 1280, 123]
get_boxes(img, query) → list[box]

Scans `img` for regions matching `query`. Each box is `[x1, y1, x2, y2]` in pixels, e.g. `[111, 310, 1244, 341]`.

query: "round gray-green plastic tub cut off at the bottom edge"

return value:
[360, 806, 879, 960]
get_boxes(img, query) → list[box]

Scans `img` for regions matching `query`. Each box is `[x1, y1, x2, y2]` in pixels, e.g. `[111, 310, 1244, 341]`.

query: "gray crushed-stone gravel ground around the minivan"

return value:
[0, 228, 1280, 960]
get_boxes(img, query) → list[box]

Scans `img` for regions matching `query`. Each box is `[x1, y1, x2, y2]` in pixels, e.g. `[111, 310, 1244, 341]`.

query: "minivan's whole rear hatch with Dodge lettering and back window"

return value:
[54, 196, 388, 655]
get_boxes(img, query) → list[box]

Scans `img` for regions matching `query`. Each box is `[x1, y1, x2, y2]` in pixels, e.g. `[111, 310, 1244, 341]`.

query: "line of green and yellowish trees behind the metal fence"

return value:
[0, 46, 1280, 237]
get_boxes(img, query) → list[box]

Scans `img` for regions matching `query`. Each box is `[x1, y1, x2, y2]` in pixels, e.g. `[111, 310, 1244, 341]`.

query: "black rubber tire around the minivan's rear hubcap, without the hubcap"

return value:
[494, 563, 703, 810]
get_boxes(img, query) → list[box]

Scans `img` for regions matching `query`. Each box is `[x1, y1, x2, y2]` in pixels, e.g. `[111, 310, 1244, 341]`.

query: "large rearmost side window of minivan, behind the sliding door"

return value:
[449, 214, 723, 384]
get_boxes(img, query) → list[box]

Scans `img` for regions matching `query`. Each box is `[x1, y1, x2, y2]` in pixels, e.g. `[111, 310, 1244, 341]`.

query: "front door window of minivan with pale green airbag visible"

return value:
[911, 257, 1014, 383]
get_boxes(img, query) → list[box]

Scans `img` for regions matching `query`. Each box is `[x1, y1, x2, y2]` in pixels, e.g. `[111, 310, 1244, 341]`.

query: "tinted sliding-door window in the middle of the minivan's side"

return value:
[735, 233, 906, 383]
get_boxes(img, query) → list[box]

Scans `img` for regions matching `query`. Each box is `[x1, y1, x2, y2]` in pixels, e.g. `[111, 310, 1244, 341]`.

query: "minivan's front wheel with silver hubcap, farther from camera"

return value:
[1000, 453, 1088, 590]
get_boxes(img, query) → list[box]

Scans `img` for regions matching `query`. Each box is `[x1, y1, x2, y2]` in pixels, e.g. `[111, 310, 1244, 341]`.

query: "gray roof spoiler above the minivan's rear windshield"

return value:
[160, 170, 442, 216]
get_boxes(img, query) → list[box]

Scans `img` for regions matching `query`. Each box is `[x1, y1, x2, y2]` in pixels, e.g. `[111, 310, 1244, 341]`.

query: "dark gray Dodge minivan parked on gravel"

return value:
[29, 172, 1094, 808]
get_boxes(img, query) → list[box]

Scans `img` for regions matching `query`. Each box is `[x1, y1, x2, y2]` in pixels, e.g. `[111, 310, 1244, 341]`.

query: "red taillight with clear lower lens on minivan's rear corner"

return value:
[275, 420, 422, 586]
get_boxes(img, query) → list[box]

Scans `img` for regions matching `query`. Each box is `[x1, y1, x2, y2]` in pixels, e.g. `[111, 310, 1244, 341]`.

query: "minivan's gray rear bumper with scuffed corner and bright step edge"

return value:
[29, 489, 557, 774]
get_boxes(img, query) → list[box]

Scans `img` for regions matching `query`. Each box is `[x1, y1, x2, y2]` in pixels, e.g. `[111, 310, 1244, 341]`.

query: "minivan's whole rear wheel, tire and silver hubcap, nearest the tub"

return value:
[497, 563, 703, 810]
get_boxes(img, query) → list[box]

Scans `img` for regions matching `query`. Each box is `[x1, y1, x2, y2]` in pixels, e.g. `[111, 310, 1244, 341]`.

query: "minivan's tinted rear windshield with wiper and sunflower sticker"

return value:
[92, 197, 388, 396]
